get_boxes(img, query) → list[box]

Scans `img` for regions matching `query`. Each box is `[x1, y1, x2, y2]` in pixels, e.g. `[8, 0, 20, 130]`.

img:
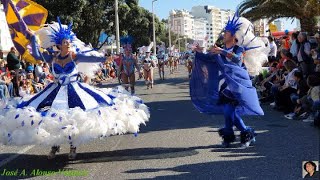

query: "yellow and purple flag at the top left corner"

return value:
[1, 0, 48, 64]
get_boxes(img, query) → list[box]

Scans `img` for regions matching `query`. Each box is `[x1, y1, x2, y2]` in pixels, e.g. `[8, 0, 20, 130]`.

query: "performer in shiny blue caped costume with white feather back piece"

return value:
[190, 13, 268, 147]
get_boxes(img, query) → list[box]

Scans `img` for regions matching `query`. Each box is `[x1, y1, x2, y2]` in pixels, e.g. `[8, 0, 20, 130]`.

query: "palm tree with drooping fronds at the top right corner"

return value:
[239, 0, 320, 32]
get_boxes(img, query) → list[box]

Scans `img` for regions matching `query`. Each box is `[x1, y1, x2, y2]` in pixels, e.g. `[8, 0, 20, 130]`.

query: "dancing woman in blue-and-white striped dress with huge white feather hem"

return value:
[0, 19, 150, 159]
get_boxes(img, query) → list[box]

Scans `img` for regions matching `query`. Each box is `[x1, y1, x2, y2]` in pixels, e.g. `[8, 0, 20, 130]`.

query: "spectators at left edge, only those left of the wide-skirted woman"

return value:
[0, 47, 53, 99]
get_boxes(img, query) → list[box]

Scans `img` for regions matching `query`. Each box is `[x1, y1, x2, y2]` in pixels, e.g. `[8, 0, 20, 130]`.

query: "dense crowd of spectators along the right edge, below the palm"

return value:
[254, 32, 320, 126]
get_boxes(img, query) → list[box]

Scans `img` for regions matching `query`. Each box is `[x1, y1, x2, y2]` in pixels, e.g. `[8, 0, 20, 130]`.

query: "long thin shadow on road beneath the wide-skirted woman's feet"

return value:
[0, 146, 214, 179]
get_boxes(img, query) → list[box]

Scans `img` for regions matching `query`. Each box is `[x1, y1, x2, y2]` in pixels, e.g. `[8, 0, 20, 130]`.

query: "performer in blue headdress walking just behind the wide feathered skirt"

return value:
[120, 36, 140, 94]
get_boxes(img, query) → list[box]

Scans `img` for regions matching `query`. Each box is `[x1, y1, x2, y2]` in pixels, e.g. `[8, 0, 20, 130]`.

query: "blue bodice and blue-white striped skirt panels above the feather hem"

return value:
[18, 54, 112, 111]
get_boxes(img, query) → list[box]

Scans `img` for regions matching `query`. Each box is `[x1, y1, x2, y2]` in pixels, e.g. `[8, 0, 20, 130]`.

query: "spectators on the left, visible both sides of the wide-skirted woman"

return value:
[0, 47, 117, 99]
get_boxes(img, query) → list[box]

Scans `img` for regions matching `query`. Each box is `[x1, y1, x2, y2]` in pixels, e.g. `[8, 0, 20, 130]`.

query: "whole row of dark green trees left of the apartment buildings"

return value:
[35, 0, 168, 49]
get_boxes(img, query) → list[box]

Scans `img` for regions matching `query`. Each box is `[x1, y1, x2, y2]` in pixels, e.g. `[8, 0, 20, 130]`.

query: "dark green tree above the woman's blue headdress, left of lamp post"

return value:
[36, 0, 110, 45]
